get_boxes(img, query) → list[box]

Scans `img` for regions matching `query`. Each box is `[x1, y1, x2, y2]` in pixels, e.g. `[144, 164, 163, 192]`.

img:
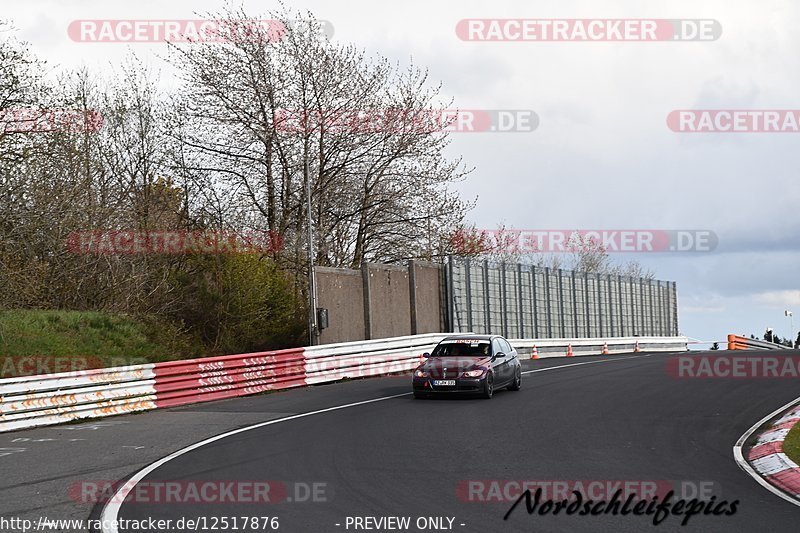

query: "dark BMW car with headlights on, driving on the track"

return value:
[413, 335, 522, 399]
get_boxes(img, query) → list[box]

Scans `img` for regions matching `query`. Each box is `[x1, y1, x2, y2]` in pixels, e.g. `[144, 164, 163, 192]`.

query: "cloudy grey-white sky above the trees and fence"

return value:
[6, 0, 800, 340]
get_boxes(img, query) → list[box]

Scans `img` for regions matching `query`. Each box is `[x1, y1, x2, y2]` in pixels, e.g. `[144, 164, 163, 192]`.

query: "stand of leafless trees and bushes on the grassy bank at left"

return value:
[0, 9, 490, 349]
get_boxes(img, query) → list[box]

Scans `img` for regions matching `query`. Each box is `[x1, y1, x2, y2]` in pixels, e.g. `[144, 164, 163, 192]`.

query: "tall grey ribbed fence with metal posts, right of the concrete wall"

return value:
[446, 257, 679, 339]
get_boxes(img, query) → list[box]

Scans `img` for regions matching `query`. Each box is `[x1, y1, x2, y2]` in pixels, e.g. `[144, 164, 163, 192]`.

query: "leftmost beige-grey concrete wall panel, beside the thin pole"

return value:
[316, 267, 366, 344]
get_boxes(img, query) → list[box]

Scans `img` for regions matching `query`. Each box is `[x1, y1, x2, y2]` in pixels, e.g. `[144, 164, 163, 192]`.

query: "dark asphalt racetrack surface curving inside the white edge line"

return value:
[94, 354, 800, 533]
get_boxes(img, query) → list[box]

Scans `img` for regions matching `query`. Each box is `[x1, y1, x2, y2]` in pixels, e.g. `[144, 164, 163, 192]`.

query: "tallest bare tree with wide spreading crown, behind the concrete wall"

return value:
[166, 10, 469, 272]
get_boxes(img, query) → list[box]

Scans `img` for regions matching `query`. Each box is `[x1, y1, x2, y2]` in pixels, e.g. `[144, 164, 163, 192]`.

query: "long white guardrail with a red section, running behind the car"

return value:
[0, 333, 687, 432]
